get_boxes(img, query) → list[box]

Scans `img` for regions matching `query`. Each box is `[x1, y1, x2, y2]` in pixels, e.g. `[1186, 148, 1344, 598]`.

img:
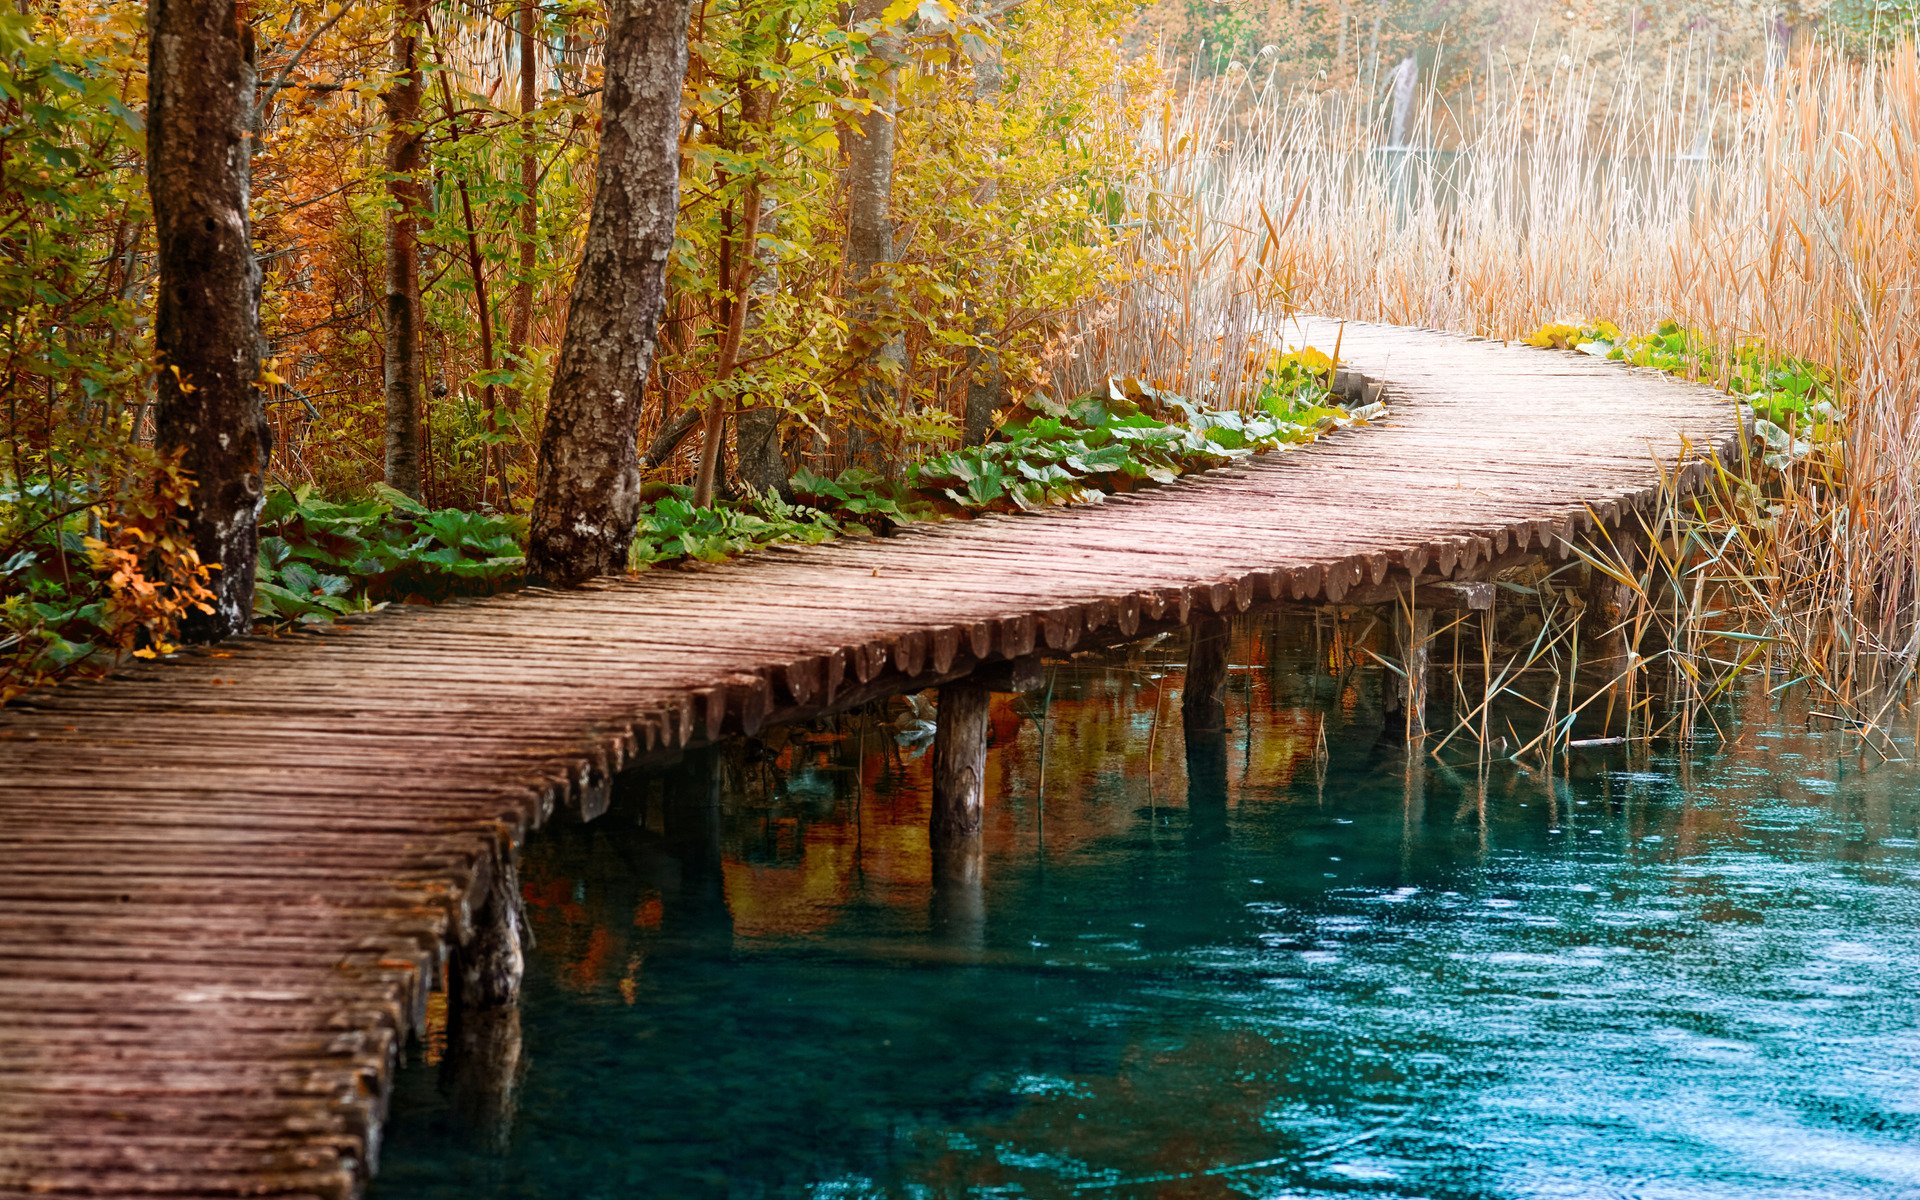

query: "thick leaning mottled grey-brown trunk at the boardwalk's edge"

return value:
[528, 0, 691, 584]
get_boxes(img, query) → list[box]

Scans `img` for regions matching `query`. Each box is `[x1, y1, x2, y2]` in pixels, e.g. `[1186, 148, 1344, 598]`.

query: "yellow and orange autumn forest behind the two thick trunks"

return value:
[0, 0, 1914, 689]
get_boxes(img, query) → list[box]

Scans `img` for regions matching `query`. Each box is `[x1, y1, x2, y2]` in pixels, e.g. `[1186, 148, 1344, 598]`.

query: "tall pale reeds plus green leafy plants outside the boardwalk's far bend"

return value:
[1169, 35, 1920, 755]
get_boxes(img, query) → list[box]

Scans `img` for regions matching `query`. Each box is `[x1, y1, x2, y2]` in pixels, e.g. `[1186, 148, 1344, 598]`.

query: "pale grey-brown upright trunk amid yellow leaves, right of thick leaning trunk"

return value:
[845, 0, 906, 465]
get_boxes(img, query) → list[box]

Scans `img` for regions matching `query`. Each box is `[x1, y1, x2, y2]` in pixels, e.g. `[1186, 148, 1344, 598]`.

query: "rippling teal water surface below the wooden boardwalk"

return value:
[374, 628, 1920, 1200]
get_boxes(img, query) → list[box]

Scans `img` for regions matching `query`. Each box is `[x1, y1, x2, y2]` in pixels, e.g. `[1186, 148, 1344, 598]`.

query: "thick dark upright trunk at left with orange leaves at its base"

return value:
[146, 0, 271, 641]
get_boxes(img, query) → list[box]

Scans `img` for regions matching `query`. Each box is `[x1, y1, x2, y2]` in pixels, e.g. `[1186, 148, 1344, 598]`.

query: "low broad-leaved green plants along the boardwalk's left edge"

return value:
[0, 349, 1379, 701]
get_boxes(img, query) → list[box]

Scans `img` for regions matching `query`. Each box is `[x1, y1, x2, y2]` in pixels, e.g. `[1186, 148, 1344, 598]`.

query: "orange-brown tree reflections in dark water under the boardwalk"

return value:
[522, 606, 1371, 1002]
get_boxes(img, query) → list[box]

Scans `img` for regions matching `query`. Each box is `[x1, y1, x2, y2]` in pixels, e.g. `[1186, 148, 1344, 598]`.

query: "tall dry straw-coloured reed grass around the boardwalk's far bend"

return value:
[1081, 42, 1920, 720]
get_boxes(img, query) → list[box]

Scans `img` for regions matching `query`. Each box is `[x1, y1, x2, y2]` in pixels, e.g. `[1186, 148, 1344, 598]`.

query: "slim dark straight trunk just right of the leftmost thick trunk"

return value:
[386, 0, 426, 499]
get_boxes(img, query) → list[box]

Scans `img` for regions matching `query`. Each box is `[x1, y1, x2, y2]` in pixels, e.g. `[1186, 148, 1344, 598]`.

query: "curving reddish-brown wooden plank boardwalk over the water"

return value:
[0, 324, 1736, 1196]
